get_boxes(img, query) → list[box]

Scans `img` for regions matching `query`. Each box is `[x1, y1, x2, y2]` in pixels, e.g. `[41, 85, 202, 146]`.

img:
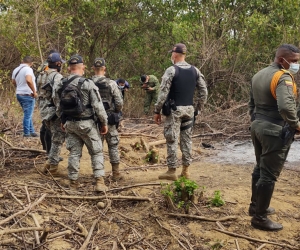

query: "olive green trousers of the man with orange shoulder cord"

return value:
[251, 120, 291, 184]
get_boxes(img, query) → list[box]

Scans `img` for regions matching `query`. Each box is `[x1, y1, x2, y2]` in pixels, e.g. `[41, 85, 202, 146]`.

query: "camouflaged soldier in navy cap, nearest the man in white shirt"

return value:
[37, 52, 65, 174]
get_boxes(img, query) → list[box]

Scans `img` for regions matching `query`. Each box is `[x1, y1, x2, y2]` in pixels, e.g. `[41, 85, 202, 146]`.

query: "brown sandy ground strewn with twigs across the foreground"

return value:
[0, 126, 300, 250]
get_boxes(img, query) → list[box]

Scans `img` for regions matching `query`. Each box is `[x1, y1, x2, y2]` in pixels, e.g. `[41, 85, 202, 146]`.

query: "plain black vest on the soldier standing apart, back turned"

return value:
[170, 65, 198, 106]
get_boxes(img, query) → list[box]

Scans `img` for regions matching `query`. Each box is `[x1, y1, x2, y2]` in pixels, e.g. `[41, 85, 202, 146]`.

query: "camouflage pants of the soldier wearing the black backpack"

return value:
[65, 120, 105, 180]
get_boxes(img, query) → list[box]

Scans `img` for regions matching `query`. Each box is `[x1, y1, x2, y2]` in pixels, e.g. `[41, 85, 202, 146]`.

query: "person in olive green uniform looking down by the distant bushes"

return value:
[141, 75, 159, 115]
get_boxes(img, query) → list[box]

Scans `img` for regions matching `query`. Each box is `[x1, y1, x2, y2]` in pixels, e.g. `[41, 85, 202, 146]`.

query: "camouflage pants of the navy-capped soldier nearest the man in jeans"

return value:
[46, 118, 66, 165]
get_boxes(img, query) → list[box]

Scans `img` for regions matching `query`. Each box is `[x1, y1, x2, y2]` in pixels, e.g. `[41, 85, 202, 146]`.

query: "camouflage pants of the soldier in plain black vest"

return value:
[164, 106, 194, 168]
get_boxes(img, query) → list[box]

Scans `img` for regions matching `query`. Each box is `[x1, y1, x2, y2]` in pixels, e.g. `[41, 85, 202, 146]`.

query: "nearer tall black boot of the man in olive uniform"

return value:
[251, 182, 283, 231]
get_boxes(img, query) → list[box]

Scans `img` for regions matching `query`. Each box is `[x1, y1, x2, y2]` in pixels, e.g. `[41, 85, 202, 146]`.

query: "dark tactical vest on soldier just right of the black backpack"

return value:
[95, 76, 115, 112]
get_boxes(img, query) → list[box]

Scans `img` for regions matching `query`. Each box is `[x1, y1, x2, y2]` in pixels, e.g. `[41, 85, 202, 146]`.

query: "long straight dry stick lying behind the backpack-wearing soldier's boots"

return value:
[47, 195, 152, 201]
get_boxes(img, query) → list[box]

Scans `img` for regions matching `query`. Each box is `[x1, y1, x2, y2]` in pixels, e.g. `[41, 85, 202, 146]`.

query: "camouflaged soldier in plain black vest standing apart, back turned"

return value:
[154, 43, 207, 180]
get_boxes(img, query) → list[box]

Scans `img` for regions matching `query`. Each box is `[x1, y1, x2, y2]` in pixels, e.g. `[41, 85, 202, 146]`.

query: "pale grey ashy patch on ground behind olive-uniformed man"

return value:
[205, 140, 300, 171]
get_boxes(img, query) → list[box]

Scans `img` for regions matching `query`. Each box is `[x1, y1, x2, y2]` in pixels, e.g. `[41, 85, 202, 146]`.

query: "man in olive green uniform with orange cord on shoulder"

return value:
[249, 44, 300, 231]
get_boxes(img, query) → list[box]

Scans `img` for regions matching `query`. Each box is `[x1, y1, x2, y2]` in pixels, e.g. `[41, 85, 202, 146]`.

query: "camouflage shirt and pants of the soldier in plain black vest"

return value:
[155, 62, 207, 168]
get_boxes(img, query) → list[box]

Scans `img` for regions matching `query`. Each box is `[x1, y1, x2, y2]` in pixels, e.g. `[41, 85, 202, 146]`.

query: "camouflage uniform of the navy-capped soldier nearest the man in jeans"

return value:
[37, 69, 65, 166]
